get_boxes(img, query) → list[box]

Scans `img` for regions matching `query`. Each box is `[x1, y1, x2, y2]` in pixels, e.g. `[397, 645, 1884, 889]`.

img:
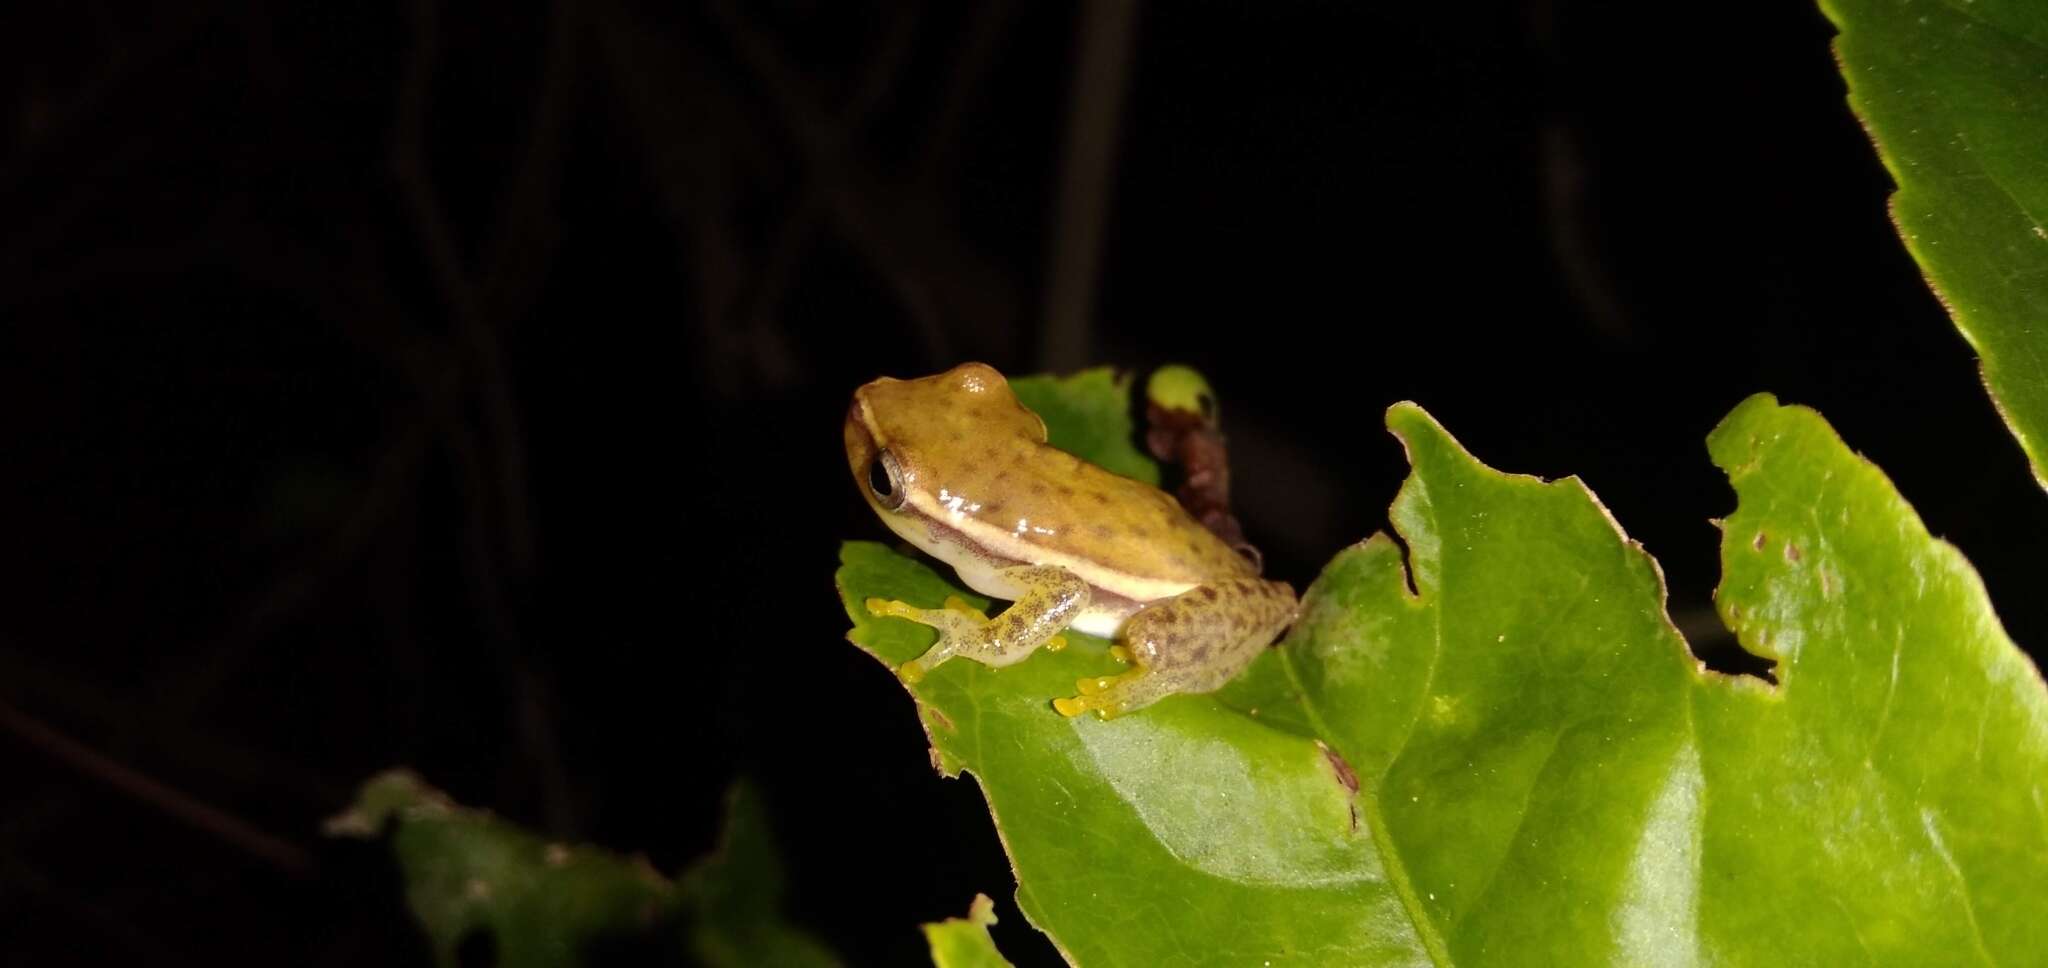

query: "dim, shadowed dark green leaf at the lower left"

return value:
[326, 769, 838, 968]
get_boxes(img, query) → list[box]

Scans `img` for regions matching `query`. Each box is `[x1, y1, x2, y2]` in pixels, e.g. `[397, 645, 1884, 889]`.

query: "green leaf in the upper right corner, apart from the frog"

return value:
[1821, 0, 2048, 485]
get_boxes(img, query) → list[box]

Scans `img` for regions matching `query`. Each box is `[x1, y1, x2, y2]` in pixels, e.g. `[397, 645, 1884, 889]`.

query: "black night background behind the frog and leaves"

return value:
[0, 0, 2048, 964]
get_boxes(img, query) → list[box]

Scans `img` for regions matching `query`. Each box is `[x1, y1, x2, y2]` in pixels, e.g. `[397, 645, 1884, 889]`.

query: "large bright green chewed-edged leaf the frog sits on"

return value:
[840, 370, 2048, 966]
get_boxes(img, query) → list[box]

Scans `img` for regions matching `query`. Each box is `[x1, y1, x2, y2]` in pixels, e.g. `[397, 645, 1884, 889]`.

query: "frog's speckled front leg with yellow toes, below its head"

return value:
[868, 565, 1087, 684]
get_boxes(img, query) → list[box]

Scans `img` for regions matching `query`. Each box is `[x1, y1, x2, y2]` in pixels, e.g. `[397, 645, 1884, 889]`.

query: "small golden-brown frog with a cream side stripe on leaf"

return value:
[844, 362, 1298, 718]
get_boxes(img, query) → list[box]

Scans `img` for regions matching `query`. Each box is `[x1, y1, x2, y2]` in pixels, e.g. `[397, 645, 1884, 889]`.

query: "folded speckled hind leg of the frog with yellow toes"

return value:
[1053, 577, 1296, 718]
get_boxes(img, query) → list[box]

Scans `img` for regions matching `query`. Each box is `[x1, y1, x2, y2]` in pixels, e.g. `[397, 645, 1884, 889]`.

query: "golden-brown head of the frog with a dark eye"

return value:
[846, 362, 1044, 542]
